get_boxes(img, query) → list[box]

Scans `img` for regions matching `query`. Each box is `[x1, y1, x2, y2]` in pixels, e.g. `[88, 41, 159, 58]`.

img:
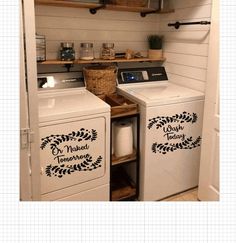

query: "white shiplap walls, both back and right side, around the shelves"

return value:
[36, 0, 211, 92]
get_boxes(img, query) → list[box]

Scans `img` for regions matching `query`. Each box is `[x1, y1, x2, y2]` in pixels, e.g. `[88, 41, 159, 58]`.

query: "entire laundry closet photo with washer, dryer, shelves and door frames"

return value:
[20, 0, 220, 203]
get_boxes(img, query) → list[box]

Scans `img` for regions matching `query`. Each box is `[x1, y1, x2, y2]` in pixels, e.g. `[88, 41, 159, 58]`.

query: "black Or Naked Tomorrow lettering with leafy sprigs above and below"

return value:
[40, 128, 102, 178]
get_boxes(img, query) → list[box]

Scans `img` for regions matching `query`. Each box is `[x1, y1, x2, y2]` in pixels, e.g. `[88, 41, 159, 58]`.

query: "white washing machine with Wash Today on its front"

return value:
[118, 67, 204, 201]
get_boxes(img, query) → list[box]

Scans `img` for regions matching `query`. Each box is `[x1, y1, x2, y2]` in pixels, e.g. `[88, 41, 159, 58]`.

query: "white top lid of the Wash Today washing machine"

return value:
[120, 83, 204, 106]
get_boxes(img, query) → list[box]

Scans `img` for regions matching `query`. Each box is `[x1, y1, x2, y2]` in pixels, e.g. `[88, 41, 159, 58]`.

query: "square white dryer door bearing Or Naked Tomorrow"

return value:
[40, 117, 106, 194]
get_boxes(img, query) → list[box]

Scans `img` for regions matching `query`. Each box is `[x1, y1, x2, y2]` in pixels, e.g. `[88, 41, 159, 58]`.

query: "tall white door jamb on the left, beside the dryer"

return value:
[22, 0, 41, 201]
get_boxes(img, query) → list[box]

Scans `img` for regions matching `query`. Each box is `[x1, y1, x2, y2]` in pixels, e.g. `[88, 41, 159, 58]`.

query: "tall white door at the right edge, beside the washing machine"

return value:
[198, 0, 220, 201]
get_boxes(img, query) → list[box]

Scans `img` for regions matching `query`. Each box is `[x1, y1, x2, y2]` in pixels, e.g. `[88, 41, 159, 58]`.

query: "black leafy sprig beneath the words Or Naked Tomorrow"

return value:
[45, 156, 102, 178]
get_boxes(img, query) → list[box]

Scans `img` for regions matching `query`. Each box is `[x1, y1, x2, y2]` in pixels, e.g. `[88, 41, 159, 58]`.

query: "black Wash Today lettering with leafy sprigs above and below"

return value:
[148, 111, 201, 154]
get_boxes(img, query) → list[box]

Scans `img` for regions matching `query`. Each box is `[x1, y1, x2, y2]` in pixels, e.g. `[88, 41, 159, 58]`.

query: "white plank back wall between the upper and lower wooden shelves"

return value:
[36, 6, 159, 59]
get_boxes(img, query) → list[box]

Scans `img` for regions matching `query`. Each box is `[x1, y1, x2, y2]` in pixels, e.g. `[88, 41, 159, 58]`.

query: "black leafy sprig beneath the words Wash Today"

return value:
[152, 136, 201, 154]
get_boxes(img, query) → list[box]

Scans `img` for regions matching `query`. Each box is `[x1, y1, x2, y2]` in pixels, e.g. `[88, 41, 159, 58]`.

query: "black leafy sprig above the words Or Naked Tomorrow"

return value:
[40, 128, 97, 150]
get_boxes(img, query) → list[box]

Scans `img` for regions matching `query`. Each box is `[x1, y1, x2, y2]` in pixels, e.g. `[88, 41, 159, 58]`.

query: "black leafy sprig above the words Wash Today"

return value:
[148, 111, 198, 129]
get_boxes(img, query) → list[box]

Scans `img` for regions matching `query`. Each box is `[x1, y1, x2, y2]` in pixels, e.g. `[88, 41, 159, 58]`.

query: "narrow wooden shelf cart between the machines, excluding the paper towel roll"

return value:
[100, 94, 140, 201]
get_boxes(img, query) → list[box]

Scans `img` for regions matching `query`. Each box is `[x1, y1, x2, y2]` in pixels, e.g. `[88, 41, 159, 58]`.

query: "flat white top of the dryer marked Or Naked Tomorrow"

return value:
[39, 90, 110, 122]
